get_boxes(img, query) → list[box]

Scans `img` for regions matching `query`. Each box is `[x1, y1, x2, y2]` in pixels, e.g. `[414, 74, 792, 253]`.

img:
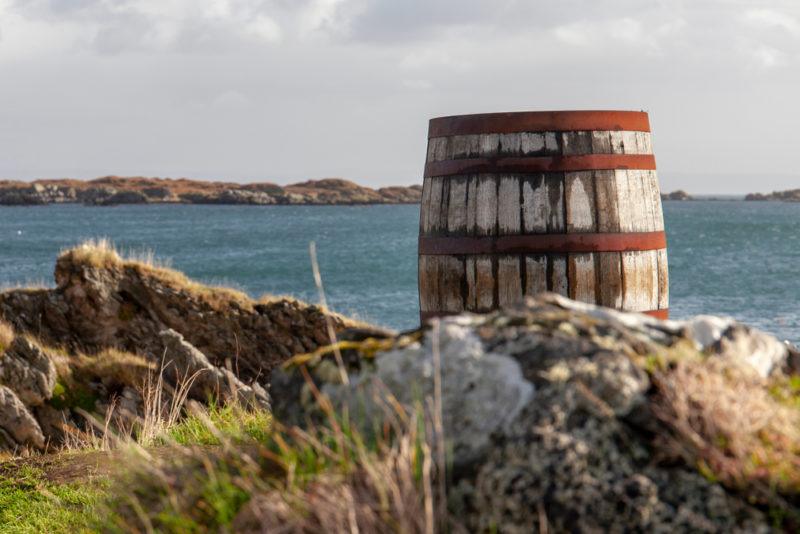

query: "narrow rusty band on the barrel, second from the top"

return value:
[425, 154, 656, 178]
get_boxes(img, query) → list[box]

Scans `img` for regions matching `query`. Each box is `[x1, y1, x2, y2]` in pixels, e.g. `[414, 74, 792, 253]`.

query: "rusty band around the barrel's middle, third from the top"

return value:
[419, 232, 667, 256]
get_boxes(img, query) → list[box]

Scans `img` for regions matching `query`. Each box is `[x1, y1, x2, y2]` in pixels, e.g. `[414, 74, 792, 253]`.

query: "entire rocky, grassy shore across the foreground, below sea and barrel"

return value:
[0, 245, 800, 533]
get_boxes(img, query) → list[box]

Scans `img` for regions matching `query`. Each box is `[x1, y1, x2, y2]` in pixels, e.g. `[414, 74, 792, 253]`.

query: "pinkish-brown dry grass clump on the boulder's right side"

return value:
[653, 357, 800, 505]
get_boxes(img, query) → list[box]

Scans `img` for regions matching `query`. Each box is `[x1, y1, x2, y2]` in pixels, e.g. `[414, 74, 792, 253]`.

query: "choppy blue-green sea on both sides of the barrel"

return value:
[0, 200, 800, 342]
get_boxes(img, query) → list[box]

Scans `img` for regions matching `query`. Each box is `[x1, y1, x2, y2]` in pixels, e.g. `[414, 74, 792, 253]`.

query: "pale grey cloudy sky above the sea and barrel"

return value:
[0, 0, 800, 194]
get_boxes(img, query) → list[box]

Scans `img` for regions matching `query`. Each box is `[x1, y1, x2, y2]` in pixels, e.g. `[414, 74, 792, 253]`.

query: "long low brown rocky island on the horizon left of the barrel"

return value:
[0, 176, 422, 206]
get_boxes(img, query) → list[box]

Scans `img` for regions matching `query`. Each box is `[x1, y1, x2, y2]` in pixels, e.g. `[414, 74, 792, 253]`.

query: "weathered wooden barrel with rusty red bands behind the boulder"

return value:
[419, 111, 669, 321]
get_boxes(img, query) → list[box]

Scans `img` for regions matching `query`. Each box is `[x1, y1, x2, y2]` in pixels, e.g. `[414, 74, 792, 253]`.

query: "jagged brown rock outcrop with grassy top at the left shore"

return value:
[0, 243, 368, 453]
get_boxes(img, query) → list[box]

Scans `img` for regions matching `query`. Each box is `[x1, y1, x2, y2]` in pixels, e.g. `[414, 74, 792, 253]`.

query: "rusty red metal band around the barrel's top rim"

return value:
[428, 111, 650, 138]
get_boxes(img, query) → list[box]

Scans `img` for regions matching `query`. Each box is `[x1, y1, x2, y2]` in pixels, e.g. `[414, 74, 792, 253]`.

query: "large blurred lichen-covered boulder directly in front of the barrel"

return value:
[275, 295, 800, 532]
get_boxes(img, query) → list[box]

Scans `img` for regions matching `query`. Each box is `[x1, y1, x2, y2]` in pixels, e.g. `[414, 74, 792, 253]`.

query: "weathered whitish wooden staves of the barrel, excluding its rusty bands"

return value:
[419, 123, 669, 313]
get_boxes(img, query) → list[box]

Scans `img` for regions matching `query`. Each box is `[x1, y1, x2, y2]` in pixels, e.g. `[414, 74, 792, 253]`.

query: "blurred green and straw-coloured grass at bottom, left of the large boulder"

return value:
[101, 404, 444, 533]
